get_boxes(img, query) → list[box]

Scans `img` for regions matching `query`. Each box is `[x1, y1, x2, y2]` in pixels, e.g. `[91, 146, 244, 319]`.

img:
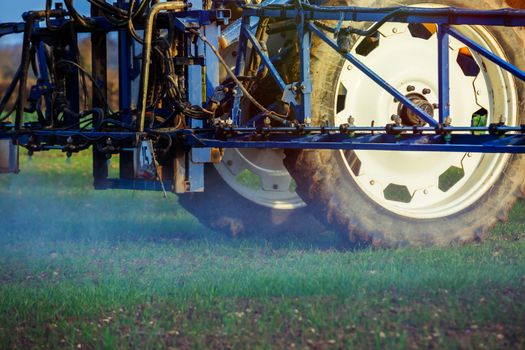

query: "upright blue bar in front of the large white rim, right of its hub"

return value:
[438, 24, 450, 124]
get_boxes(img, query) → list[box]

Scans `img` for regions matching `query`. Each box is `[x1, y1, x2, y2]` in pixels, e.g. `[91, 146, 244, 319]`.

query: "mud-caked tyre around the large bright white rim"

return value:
[285, 0, 525, 247]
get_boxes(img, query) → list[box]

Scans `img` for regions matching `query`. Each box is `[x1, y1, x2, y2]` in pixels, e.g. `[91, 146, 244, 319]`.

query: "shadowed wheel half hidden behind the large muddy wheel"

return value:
[179, 38, 325, 236]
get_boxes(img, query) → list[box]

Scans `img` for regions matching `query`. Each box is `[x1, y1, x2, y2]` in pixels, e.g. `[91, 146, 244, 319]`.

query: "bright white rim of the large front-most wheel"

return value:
[334, 4, 517, 219]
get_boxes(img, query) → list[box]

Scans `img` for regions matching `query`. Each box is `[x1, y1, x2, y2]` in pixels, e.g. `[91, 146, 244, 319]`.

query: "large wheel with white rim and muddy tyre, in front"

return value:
[285, 0, 525, 246]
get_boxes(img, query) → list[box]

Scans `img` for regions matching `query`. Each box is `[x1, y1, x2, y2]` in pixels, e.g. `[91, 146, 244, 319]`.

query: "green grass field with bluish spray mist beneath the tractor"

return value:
[0, 153, 525, 349]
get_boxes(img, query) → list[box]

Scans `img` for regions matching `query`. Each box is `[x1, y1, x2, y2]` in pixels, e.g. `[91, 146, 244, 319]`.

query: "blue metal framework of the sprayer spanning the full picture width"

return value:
[0, 0, 525, 191]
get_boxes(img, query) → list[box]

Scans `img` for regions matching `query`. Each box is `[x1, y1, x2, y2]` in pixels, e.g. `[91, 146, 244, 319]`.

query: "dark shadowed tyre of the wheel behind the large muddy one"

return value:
[179, 164, 324, 237]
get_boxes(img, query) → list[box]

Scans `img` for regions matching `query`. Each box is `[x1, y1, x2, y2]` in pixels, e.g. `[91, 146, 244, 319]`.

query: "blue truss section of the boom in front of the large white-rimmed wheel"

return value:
[224, 2, 525, 153]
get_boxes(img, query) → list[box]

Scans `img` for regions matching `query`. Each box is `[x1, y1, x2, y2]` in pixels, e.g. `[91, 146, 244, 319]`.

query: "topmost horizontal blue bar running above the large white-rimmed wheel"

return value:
[244, 4, 525, 27]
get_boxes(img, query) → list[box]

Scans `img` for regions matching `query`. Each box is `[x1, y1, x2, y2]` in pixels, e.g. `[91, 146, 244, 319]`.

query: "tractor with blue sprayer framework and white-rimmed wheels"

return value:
[0, 0, 525, 247]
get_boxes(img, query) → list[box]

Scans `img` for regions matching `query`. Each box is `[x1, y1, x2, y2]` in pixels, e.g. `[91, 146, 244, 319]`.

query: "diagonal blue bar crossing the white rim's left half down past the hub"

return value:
[308, 23, 439, 126]
